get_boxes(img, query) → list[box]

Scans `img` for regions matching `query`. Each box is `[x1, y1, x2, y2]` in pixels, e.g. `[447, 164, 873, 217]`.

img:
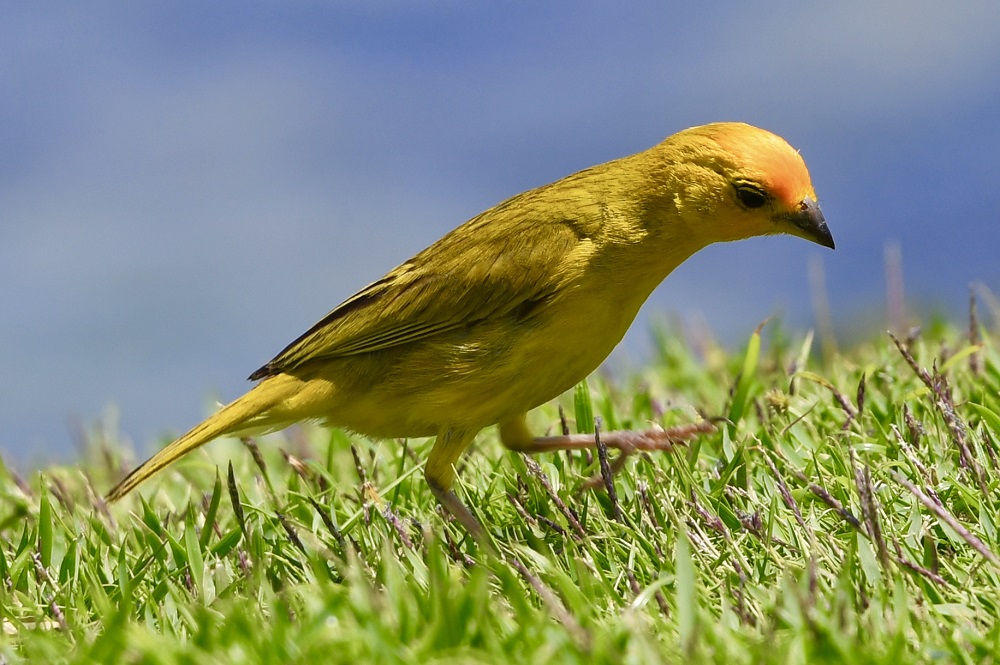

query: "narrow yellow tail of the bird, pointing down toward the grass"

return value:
[107, 374, 302, 501]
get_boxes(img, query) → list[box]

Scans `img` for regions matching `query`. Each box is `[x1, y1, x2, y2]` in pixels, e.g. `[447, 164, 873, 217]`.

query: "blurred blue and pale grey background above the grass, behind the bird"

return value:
[0, 0, 1000, 465]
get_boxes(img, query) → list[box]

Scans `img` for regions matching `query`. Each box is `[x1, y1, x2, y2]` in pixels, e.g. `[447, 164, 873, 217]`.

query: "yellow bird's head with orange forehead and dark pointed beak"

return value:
[660, 122, 834, 249]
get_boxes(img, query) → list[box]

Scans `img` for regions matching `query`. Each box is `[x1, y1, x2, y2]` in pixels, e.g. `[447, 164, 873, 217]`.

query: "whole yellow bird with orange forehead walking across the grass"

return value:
[108, 123, 834, 536]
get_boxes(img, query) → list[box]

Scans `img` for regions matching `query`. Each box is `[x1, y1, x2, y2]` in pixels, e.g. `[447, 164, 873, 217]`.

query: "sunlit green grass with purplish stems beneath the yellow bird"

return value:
[0, 324, 1000, 664]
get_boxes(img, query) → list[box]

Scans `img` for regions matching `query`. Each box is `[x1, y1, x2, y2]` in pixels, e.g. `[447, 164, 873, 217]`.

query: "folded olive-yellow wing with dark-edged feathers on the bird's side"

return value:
[250, 190, 600, 380]
